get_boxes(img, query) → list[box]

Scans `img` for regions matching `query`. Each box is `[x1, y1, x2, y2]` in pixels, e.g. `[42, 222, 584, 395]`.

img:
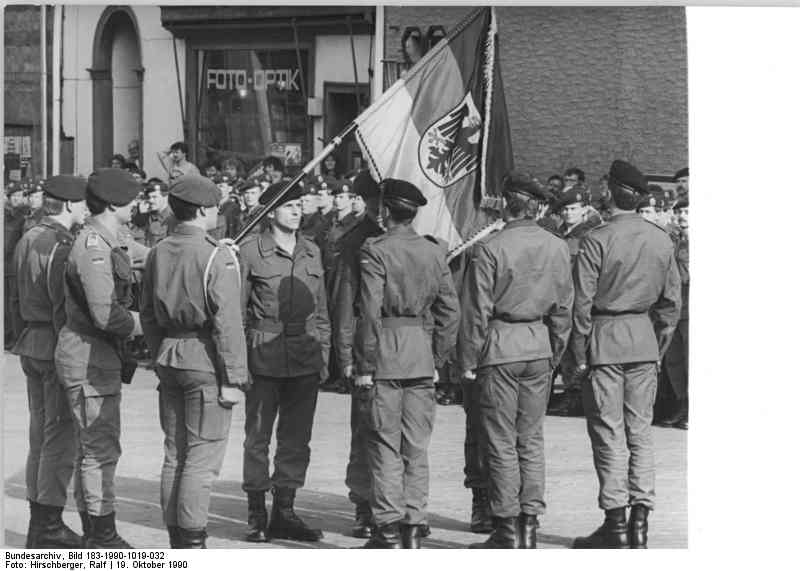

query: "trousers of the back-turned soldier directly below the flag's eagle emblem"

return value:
[367, 377, 436, 526]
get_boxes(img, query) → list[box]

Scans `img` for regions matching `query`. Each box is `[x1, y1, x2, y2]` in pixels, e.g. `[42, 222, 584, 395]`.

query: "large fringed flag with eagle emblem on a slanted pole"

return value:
[355, 8, 513, 248]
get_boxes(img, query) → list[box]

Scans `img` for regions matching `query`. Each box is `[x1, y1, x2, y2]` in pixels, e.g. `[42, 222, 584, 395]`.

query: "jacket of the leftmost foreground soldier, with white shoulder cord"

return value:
[11, 216, 74, 361]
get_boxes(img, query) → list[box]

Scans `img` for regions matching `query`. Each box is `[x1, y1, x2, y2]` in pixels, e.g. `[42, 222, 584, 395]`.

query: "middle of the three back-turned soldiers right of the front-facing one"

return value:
[458, 172, 580, 549]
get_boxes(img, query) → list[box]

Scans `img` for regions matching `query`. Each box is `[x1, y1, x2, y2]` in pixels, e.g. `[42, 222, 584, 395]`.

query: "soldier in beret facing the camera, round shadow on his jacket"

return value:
[239, 181, 330, 542]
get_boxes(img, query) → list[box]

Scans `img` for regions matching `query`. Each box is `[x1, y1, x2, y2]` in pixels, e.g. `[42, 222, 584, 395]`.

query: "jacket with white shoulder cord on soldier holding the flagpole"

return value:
[140, 224, 248, 385]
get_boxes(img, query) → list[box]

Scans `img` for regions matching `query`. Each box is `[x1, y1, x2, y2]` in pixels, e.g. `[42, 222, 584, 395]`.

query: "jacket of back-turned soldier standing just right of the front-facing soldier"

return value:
[353, 225, 460, 379]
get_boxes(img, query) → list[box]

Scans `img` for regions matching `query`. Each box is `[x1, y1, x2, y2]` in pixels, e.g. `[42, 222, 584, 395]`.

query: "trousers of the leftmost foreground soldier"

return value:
[20, 356, 75, 507]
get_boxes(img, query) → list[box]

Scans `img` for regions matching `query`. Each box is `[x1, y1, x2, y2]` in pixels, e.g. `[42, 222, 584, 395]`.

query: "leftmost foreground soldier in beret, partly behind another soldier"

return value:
[12, 176, 86, 549]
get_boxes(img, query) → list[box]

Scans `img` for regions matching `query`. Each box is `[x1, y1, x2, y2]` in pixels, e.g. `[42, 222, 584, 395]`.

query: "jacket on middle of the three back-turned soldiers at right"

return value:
[458, 219, 573, 371]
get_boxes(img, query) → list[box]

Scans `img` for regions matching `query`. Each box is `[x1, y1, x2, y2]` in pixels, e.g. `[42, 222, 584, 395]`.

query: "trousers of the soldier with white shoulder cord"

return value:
[157, 366, 233, 531]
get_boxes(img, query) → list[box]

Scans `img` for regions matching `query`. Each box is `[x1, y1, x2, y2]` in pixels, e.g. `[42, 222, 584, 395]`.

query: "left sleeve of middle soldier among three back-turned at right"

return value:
[458, 243, 497, 371]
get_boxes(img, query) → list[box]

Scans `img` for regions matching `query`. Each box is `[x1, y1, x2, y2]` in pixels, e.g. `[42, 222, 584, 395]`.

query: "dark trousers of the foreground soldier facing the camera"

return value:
[242, 373, 320, 492]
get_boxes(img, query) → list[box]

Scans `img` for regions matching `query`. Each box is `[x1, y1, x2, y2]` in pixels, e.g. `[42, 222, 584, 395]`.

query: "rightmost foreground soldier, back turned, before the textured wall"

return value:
[571, 161, 681, 549]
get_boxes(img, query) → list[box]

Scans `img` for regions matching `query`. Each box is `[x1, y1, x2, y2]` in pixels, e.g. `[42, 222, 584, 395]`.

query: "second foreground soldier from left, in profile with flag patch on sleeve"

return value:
[55, 169, 142, 549]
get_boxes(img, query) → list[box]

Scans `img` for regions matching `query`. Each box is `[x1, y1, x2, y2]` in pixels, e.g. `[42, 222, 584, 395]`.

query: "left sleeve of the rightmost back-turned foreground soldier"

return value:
[571, 235, 603, 365]
